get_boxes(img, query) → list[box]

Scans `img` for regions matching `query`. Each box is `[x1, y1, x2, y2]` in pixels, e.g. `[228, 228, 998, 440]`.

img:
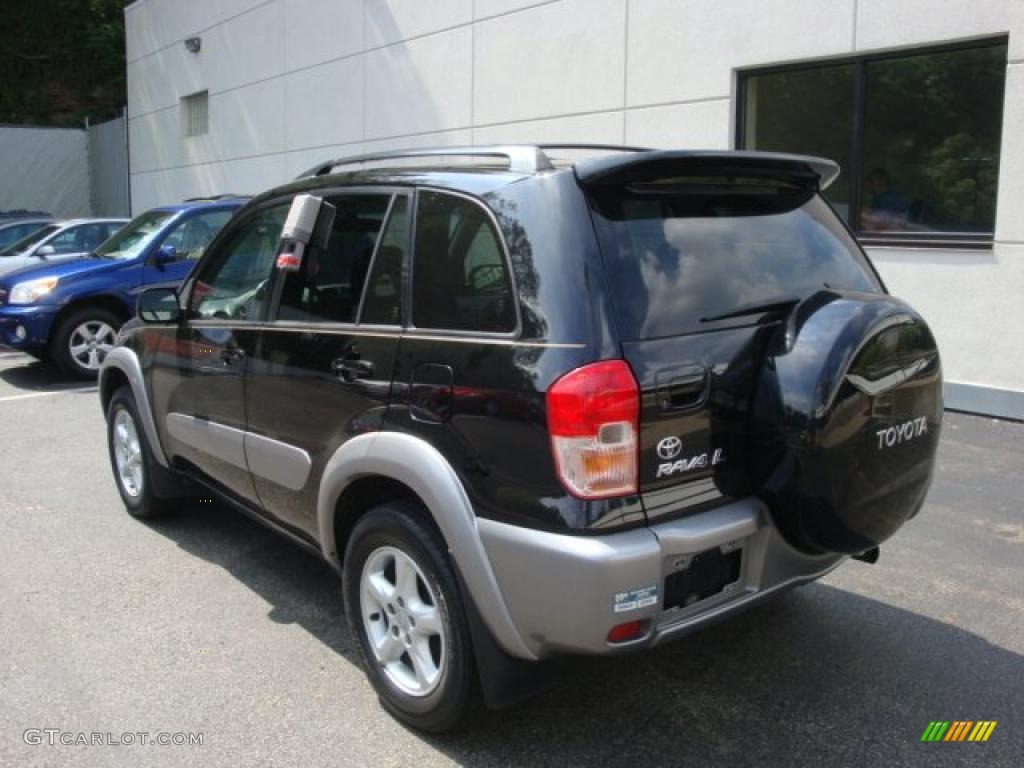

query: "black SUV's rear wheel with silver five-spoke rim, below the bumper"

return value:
[343, 502, 477, 733]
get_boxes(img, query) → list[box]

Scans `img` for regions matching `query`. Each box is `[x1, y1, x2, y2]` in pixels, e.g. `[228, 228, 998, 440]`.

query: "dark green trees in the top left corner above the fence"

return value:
[0, 0, 128, 126]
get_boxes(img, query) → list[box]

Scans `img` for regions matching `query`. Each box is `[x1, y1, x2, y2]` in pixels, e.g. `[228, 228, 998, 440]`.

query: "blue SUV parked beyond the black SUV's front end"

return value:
[0, 197, 247, 378]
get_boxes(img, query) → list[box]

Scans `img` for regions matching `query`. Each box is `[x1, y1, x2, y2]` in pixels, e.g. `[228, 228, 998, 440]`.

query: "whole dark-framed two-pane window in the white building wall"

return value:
[737, 38, 1007, 245]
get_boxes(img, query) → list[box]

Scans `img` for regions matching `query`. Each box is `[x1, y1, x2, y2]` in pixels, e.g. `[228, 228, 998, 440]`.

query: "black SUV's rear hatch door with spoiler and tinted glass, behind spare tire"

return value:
[577, 152, 884, 521]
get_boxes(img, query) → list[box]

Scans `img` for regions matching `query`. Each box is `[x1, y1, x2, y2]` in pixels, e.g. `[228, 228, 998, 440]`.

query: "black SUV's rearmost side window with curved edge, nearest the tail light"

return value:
[413, 191, 516, 333]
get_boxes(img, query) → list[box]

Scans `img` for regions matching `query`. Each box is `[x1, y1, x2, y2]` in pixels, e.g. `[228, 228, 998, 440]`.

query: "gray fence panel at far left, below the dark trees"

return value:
[0, 126, 92, 217]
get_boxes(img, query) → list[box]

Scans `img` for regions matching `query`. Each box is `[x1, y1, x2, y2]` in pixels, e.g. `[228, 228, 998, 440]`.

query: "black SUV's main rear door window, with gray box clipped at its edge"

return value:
[278, 195, 391, 323]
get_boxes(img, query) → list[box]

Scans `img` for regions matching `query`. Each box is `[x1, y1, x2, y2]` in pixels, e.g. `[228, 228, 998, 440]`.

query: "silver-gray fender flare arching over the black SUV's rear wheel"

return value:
[316, 432, 537, 660]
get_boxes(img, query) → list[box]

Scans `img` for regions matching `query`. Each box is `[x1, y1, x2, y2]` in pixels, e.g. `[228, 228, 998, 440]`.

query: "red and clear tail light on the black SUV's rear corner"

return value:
[547, 360, 640, 499]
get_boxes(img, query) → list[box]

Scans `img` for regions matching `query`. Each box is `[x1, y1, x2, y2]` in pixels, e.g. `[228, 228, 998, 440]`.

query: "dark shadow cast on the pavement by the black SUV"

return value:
[152, 505, 1024, 768]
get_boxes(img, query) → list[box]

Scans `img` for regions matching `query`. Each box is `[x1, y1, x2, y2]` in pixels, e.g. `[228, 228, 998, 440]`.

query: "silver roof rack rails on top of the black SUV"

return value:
[296, 144, 646, 178]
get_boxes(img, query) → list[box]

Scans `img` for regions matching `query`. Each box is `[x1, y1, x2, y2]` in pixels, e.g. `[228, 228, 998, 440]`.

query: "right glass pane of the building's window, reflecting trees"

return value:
[860, 46, 1007, 232]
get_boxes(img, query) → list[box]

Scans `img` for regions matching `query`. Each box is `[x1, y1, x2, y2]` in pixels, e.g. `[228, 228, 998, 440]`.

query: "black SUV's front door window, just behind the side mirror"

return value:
[189, 206, 288, 319]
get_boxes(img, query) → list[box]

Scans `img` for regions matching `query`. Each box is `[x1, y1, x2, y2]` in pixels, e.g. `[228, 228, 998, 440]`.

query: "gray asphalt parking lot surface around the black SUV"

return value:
[0, 354, 1024, 768]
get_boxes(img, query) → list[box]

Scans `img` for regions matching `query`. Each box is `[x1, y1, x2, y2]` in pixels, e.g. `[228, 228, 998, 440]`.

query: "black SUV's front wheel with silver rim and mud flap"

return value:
[106, 386, 185, 519]
